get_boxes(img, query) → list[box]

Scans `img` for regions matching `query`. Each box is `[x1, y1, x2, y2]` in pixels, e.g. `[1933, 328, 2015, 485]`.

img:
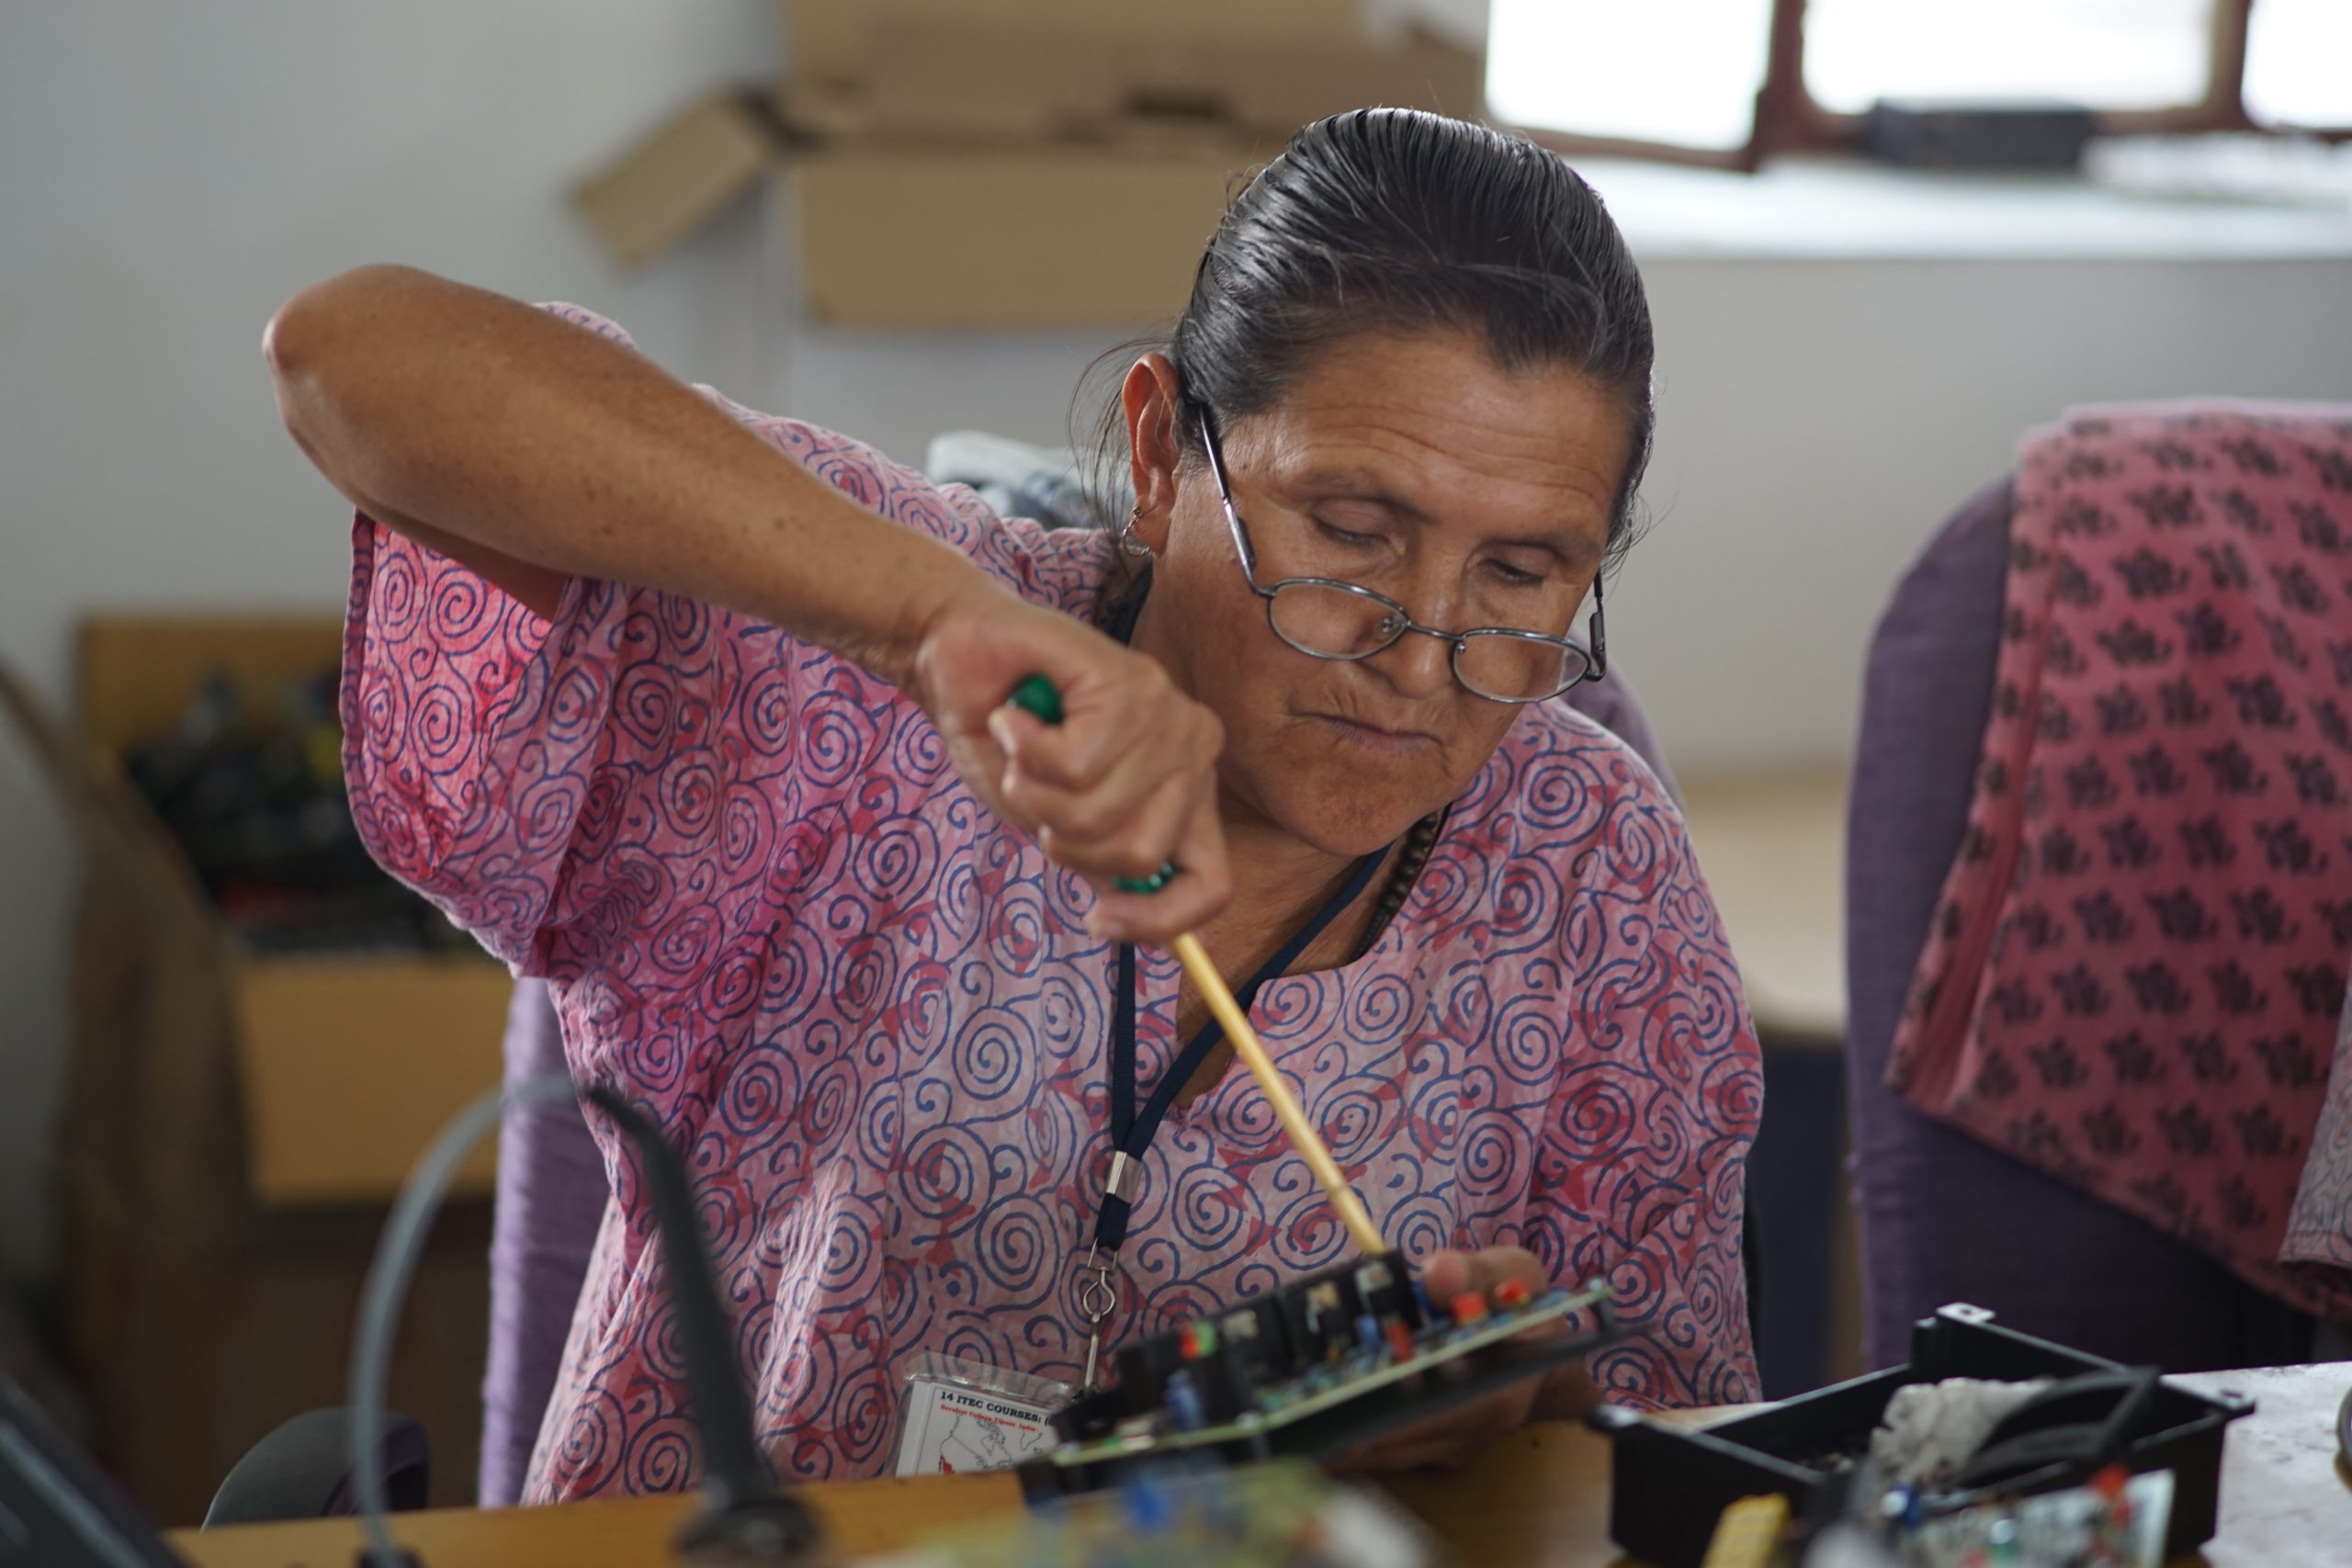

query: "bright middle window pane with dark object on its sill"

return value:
[1804, 0, 2211, 115]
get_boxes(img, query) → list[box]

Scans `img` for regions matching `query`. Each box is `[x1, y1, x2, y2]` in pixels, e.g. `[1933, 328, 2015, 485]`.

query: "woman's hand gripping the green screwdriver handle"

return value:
[910, 585, 1232, 945]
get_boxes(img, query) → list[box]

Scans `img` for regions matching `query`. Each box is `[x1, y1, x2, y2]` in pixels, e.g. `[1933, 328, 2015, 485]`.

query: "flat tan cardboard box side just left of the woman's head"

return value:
[790, 148, 1251, 327]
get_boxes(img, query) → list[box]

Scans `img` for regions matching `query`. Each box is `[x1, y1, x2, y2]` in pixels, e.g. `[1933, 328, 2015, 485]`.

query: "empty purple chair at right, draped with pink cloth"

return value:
[1847, 479, 2312, 1371]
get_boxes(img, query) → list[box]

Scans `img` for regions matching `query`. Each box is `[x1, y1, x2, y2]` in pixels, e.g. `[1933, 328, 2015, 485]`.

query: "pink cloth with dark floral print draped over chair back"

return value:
[1886, 404, 2352, 1319]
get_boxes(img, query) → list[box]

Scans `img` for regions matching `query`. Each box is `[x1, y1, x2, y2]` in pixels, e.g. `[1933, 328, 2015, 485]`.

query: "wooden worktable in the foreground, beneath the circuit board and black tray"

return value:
[172, 1361, 2352, 1568]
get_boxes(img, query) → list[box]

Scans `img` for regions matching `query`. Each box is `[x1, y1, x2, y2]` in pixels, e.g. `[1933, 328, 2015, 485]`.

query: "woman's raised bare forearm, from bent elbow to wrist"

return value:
[264, 268, 1000, 684]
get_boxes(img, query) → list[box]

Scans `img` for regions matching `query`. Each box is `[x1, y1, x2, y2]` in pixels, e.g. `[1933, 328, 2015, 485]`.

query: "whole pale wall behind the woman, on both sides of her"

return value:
[0, 0, 2352, 1272]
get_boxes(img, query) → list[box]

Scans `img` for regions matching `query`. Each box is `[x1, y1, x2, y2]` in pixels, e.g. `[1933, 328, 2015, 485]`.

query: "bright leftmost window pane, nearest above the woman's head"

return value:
[1487, 0, 1771, 151]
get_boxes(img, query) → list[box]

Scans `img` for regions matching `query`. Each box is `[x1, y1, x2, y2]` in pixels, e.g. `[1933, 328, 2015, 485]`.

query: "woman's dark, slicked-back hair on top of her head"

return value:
[1101, 108, 1654, 566]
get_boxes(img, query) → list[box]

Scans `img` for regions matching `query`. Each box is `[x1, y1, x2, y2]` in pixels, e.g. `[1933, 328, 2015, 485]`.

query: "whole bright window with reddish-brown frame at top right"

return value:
[1487, 0, 2352, 169]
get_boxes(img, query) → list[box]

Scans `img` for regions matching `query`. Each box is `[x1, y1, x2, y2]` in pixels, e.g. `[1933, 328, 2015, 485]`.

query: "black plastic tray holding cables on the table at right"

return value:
[1592, 1304, 2253, 1568]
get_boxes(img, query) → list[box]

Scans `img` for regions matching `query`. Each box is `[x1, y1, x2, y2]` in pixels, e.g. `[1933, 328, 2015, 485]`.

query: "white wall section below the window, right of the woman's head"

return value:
[1609, 259, 2352, 773]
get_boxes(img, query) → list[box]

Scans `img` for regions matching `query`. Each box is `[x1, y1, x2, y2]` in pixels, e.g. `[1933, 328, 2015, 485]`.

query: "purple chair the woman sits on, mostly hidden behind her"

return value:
[480, 672, 1679, 1509]
